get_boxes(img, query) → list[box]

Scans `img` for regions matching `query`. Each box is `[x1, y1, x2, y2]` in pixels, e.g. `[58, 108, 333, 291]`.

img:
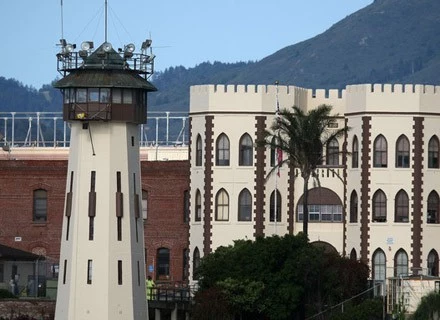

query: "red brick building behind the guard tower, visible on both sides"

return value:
[0, 150, 189, 284]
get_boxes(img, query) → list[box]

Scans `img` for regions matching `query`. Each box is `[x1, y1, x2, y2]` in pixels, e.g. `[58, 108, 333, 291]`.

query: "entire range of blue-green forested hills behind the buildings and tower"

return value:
[0, 0, 440, 111]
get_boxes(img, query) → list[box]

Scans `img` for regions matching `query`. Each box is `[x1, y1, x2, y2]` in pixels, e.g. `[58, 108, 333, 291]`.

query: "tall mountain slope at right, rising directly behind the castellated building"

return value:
[232, 0, 440, 88]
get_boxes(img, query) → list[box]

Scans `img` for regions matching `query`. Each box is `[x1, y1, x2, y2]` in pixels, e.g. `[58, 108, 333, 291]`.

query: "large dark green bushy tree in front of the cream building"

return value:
[193, 234, 368, 320]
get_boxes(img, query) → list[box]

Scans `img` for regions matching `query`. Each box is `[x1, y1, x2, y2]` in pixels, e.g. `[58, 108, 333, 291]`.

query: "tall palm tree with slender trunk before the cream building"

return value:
[257, 104, 349, 236]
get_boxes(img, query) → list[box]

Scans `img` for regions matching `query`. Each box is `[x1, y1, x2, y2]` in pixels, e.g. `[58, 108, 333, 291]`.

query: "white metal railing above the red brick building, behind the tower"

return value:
[0, 111, 189, 147]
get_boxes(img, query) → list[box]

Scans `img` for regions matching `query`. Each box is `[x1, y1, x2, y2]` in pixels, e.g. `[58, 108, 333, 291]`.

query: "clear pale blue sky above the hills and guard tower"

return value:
[0, 0, 373, 89]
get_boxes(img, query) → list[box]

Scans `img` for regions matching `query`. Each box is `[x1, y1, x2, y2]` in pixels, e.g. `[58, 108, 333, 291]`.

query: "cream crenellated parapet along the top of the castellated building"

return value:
[190, 84, 440, 115]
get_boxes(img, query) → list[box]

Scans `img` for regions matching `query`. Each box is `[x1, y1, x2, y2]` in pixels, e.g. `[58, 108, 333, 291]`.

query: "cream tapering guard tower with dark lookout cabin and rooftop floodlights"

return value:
[55, 39, 156, 320]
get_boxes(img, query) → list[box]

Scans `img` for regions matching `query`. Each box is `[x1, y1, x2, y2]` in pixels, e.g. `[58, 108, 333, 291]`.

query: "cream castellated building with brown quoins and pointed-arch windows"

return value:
[189, 84, 440, 292]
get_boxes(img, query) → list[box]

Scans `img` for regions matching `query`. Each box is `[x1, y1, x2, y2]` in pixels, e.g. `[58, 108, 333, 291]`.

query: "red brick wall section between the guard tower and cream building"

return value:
[141, 161, 189, 282]
